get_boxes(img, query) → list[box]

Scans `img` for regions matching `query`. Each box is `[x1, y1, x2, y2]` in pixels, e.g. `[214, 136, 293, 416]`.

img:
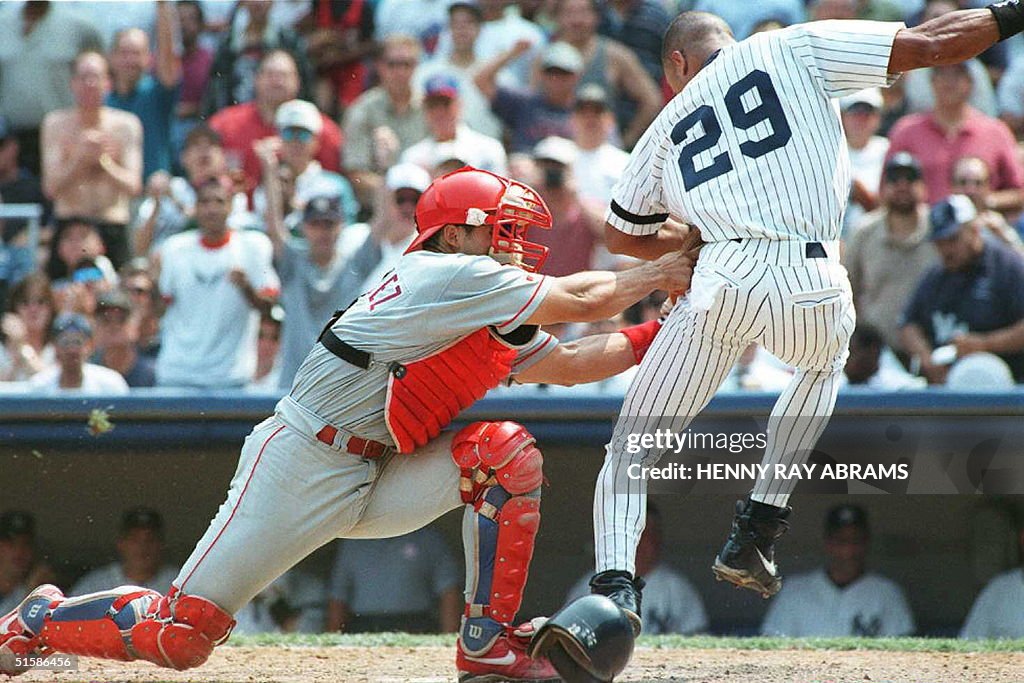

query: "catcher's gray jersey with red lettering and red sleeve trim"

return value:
[285, 251, 558, 445]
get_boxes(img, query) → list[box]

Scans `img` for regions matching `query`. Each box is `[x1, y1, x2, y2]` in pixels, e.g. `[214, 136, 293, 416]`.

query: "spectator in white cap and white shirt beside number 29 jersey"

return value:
[839, 88, 889, 233]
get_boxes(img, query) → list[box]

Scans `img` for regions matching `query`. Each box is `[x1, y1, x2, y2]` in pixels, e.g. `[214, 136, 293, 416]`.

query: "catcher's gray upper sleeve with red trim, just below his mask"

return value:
[441, 256, 551, 334]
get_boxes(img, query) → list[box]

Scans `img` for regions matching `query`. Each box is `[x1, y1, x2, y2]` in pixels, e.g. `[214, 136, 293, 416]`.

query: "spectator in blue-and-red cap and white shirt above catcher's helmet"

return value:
[400, 74, 508, 175]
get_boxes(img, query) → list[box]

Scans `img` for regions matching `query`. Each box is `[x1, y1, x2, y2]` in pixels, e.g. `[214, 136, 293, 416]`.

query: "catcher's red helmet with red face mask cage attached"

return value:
[406, 166, 552, 272]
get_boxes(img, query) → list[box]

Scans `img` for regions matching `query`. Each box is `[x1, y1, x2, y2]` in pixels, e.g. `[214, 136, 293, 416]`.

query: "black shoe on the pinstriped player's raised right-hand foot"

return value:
[712, 498, 793, 598]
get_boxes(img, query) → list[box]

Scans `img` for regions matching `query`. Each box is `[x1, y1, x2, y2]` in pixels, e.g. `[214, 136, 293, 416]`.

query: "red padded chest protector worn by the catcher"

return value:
[384, 328, 516, 453]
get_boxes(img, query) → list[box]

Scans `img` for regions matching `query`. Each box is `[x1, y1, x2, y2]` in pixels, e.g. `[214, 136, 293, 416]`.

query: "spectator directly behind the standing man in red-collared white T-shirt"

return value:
[132, 124, 261, 257]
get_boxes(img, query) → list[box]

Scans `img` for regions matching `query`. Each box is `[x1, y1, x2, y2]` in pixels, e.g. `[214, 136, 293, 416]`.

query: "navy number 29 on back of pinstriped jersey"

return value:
[672, 70, 793, 190]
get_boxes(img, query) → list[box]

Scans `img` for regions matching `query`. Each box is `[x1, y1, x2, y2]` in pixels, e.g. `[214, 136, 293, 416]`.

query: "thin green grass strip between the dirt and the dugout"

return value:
[227, 633, 1024, 652]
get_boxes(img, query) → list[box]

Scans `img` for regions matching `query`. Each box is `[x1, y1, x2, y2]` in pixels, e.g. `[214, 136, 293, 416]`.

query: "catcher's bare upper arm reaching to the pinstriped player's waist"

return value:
[525, 251, 696, 325]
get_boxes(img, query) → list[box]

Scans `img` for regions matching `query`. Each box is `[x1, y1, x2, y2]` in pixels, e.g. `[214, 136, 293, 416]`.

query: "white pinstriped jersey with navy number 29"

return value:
[606, 20, 904, 242]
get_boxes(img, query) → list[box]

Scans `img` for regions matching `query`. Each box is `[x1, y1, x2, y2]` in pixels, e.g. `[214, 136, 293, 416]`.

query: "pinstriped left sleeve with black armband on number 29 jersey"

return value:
[604, 117, 669, 236]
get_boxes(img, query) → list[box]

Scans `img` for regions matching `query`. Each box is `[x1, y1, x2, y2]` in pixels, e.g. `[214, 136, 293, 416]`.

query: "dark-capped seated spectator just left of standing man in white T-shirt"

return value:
[89, 289, 157, 387]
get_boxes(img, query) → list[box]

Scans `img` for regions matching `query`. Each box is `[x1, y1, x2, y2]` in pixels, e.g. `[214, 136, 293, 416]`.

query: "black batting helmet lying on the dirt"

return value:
[527, 595, 635, 683]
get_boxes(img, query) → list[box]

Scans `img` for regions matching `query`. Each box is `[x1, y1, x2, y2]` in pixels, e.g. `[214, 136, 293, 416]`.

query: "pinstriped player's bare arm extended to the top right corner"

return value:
[889, 0, 1011, 74]
